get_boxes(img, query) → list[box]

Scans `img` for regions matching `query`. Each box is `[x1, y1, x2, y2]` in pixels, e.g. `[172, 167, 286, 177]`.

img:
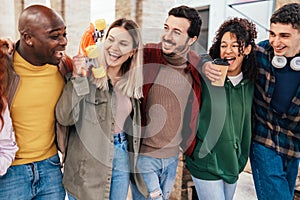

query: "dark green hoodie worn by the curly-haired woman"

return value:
[186, 76, 254, 184]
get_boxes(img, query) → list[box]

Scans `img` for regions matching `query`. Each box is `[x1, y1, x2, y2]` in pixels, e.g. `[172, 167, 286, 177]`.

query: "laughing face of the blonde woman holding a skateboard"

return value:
[104, 27, 134, 68]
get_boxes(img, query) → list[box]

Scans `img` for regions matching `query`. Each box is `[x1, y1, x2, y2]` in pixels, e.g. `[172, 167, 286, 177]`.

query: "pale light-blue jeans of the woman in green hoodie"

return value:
[192, 176, 237, 200]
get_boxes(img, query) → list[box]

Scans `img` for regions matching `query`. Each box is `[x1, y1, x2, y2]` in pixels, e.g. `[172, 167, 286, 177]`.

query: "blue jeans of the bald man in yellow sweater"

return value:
[0, 155, 65, 200]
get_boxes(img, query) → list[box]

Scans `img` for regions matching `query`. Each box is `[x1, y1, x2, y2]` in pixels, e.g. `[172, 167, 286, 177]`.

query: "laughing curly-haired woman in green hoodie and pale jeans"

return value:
[186, 18, 257, 200]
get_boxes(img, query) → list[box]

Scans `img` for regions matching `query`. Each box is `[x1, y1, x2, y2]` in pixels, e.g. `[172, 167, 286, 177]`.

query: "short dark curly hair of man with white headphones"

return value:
[270, 3, 300, 31]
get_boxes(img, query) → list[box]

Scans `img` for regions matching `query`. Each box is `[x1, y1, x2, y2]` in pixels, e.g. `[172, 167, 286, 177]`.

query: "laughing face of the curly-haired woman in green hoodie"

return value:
[220, 32, 251, 76]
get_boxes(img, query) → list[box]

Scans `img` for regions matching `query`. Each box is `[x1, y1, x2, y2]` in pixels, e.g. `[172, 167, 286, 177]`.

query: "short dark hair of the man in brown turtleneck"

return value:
[169, 6, 202, 38]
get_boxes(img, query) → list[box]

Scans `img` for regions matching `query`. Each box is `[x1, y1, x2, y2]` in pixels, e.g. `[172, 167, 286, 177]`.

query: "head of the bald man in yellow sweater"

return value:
[18, 5, 67, 66]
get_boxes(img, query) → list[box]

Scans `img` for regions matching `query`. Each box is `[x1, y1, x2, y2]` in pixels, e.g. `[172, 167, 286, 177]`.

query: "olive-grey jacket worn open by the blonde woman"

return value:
[56, 77, 146, 200]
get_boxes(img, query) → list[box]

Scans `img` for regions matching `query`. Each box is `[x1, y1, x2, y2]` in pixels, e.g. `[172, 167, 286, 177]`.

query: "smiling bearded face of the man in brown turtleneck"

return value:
[162, 15, 197, 55]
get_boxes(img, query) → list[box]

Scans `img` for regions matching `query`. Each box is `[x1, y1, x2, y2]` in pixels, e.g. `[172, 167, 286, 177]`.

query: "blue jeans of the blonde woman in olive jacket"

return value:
[68, 133, 130, 200]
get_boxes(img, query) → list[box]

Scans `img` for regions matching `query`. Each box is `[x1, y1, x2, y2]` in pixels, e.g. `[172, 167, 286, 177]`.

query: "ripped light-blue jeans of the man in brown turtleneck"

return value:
[131, 155, 178, 200]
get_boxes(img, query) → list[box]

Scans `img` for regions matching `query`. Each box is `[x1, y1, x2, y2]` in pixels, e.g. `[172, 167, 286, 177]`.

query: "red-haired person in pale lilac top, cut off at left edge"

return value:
[0, 43, 18, 176]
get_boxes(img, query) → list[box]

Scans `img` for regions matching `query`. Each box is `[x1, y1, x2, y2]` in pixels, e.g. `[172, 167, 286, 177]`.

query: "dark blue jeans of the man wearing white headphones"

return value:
[250, 142, 299, 200]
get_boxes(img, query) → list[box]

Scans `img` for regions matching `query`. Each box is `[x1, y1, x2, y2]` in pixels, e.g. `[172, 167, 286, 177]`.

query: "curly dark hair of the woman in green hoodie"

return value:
[209, 17, 257, 82]
